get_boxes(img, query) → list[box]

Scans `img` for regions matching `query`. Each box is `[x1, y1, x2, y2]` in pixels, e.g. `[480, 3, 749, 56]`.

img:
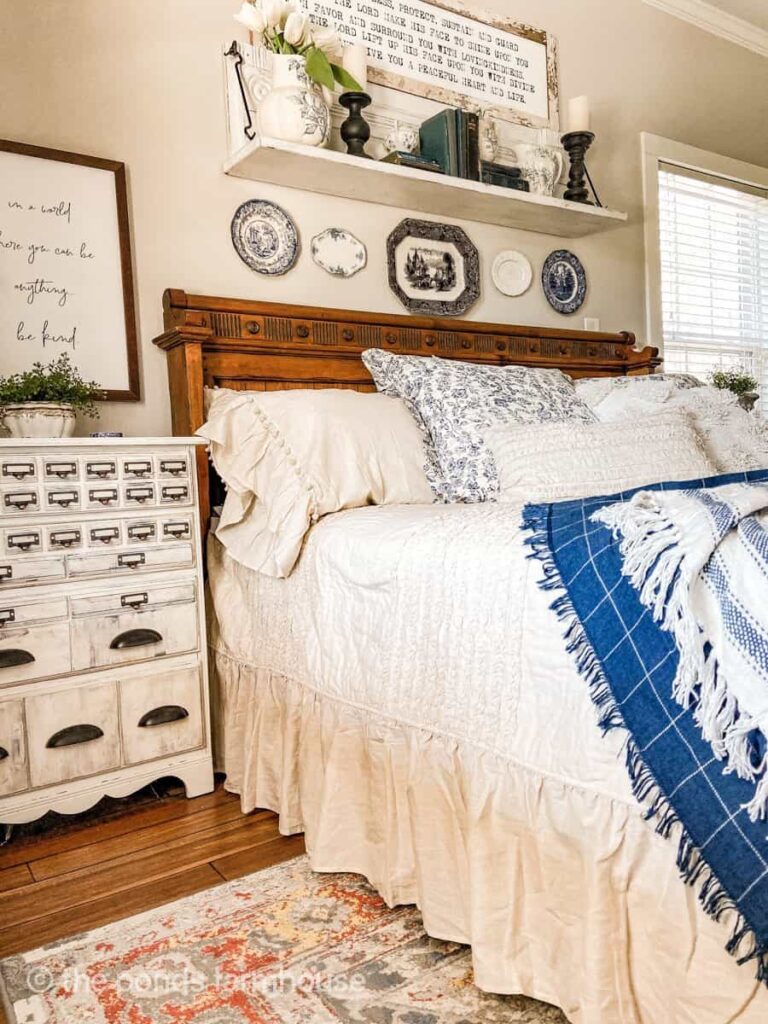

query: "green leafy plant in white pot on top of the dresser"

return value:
[0, 352, 103, 437]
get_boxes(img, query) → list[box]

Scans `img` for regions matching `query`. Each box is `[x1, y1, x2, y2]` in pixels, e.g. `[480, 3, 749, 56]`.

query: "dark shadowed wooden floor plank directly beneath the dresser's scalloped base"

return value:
[0, 785, 240, 869]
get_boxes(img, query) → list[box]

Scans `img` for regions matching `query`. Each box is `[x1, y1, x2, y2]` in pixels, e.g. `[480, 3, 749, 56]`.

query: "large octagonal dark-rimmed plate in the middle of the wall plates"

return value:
[387, 217, 480, 316]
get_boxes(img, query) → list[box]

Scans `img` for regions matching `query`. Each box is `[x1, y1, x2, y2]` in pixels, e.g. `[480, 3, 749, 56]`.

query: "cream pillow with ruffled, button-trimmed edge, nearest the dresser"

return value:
[198, 388, 434, 577]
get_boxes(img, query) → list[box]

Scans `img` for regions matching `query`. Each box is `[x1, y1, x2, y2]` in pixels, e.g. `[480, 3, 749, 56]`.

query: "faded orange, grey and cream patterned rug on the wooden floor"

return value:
[0, 857, 567, 1024]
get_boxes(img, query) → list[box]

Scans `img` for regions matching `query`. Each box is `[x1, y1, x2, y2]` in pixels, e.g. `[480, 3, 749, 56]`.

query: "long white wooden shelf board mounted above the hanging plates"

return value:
[224, 138, 627, 239]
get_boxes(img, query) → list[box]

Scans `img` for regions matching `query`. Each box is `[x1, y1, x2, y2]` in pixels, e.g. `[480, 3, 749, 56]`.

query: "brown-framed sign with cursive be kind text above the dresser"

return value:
[0, 140, 140, 401]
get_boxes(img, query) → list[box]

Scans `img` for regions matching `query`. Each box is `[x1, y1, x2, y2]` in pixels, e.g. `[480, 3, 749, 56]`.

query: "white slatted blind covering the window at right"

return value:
[658, 163, 768, 410]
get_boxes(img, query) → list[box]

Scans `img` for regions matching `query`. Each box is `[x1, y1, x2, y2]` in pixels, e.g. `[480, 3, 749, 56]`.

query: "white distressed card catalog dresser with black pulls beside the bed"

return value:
[0, 437, 213, 839]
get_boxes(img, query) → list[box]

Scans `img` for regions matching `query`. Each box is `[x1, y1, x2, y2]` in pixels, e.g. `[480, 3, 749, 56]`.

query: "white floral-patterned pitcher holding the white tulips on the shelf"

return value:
[258, 53, 331, 145]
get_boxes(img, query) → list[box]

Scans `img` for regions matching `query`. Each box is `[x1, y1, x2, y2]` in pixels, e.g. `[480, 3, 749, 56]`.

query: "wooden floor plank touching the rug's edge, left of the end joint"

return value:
[0, 864, 221, 956]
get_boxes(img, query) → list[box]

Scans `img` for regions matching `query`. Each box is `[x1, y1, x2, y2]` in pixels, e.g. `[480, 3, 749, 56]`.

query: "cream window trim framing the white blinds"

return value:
[640, 132, 768, 358]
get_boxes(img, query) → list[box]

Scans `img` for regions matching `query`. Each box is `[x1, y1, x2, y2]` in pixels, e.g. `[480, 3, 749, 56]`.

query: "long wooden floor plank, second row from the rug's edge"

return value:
[0, 815, 286, 928]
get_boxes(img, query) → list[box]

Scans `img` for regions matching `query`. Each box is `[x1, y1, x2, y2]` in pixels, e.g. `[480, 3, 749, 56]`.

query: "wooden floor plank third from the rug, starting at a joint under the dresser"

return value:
[30, 800, 259, 882]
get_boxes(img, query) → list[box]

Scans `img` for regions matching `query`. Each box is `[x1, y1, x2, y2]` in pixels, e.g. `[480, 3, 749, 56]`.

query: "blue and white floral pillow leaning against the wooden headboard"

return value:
[362, 348, 597, 502]
